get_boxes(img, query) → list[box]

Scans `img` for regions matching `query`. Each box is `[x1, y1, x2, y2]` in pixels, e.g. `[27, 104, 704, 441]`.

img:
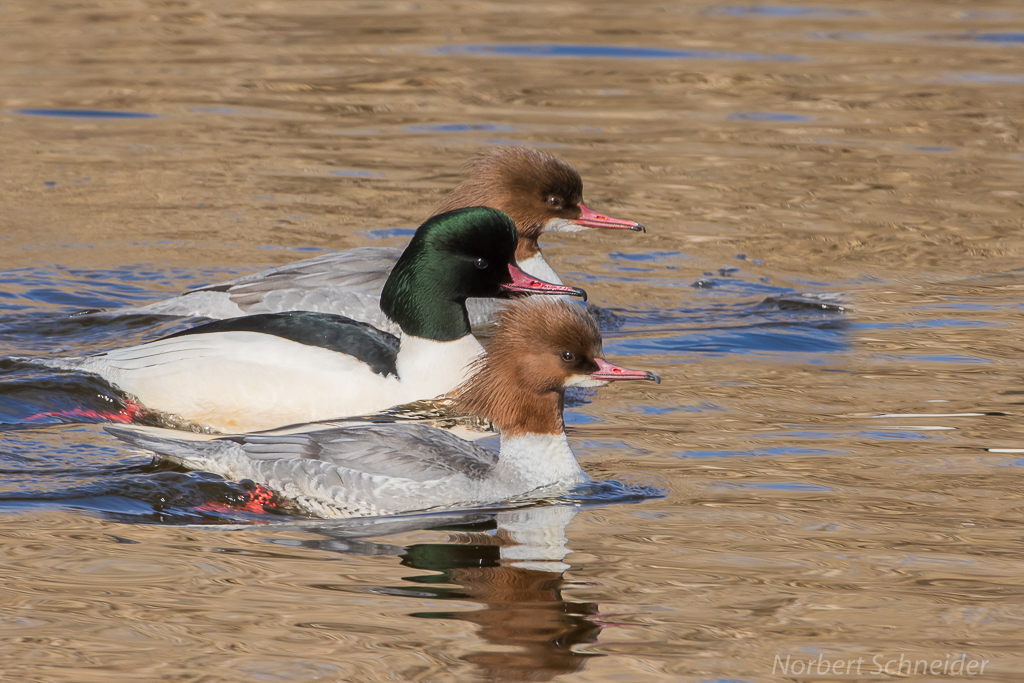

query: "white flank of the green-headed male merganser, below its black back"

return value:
[80, 332, 407, 432]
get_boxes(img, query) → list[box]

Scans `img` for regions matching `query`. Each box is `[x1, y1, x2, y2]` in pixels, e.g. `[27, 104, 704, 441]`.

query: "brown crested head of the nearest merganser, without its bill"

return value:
[456, 297, 602, 435]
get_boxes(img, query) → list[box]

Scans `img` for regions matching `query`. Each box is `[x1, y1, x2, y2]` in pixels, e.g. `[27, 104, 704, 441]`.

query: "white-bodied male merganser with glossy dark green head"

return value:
[58, 207, 587, 432]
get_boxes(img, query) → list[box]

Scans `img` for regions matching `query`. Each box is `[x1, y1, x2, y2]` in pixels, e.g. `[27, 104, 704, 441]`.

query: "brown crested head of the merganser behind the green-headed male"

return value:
[434, 145, 583, 261]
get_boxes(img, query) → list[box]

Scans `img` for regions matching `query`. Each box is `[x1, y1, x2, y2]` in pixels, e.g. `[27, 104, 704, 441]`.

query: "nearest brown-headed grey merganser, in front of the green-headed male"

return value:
[109, 299, 659, 517]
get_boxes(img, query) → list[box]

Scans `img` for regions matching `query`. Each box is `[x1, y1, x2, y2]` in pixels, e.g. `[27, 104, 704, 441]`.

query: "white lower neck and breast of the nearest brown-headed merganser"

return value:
[495, 431, 587, 494]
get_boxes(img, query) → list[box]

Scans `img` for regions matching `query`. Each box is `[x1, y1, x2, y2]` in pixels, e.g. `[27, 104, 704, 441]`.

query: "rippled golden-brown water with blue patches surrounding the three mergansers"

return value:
[0, 0, 1024, 682]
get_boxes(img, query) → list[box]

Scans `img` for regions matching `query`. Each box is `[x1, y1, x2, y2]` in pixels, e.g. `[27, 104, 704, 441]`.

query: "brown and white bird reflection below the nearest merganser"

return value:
[284, 505, 601, 681]
